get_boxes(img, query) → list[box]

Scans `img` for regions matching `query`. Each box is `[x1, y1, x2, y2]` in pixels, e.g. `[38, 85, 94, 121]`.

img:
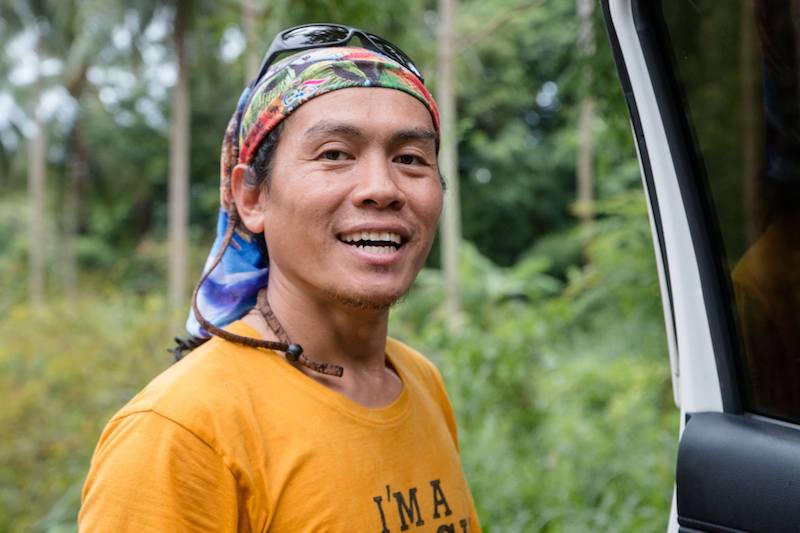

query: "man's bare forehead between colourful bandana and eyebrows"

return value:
[285, 87, 434, 136]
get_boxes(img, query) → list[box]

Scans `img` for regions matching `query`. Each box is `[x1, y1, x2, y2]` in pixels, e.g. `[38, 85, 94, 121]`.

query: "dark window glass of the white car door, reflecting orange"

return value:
[661, 0, 800, 422]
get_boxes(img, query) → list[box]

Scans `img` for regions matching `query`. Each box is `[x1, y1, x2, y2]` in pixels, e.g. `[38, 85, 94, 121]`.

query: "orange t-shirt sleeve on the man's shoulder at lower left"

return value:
[78, 411, 241, 533]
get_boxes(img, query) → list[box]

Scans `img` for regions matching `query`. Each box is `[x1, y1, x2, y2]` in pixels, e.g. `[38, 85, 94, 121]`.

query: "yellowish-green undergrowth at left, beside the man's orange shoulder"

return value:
[0, 290, 170, 531]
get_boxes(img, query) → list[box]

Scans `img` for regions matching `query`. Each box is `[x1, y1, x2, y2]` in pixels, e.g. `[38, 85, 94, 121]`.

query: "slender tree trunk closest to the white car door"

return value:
[575, 0, 594, 227]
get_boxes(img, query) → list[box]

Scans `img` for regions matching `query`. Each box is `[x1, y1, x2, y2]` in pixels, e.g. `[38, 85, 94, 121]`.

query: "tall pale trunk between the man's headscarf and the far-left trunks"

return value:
[168, 0, 190, 316]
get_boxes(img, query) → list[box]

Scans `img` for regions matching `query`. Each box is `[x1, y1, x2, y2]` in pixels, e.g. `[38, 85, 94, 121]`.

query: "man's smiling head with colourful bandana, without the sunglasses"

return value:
[187, 33, 442, 333]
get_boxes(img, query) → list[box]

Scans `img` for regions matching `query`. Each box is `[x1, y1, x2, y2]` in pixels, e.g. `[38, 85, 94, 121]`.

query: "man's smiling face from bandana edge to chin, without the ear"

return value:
[262, 88, 442, 308]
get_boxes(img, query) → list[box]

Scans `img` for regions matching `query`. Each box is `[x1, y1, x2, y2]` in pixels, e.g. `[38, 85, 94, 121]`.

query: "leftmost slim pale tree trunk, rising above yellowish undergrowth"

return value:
[28, 86, 47, 307]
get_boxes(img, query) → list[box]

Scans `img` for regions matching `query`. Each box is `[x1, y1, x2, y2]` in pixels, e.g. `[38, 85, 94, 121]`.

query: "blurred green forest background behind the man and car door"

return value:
[0, 0, 678, 532]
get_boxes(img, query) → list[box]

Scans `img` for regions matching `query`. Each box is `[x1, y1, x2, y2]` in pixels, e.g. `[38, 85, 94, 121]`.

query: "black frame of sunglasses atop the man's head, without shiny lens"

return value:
[250, 23, 425, 88]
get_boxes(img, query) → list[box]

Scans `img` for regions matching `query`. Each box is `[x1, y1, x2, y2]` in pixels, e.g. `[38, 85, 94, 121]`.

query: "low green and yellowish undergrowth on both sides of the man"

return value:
[0, 189, 678, 532]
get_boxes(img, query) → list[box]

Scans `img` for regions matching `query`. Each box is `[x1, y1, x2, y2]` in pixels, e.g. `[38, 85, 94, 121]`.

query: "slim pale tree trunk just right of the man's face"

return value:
[437, 0, 461, 318]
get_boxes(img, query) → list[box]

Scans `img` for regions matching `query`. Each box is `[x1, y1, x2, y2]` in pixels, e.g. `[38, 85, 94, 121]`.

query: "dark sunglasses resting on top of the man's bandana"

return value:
[251, 24, 425, 87]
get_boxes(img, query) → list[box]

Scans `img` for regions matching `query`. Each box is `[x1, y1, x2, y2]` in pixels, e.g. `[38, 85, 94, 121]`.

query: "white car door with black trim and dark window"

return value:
[602, 0, 800, 532]
